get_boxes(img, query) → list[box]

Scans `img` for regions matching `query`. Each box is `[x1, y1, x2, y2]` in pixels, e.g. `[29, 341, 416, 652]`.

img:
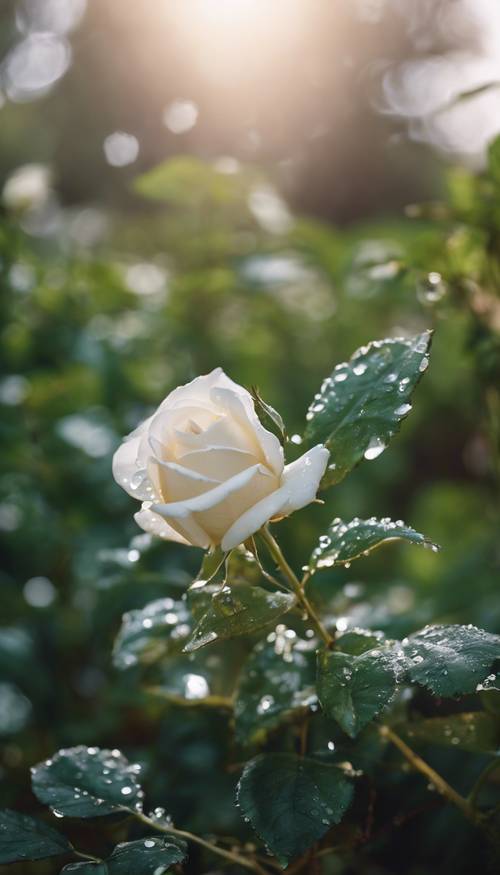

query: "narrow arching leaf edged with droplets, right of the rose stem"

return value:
[309, 517, 438, 573]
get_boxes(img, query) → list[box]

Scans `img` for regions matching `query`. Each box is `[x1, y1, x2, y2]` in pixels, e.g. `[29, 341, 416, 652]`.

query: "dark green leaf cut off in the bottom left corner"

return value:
[0, 809, 73, 864]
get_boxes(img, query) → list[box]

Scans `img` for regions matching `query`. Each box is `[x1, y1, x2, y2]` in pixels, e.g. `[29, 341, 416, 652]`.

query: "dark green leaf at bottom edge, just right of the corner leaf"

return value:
[106, 836, 186, 875]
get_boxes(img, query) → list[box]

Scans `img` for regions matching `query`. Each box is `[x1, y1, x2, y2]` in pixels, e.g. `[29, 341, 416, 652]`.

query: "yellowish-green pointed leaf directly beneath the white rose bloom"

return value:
[184, 583, 296, 653]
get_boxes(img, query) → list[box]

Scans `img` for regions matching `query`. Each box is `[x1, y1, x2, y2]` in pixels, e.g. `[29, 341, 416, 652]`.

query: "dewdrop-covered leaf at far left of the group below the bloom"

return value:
[113, 598, 192, 669]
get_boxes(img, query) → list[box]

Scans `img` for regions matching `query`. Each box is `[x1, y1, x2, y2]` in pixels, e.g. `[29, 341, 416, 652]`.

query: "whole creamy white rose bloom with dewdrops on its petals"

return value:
[113, 368, 329, 550]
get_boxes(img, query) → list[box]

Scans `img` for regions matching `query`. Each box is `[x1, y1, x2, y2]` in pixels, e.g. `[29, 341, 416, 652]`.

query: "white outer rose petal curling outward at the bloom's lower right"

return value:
[221, 444, 330, 550]
